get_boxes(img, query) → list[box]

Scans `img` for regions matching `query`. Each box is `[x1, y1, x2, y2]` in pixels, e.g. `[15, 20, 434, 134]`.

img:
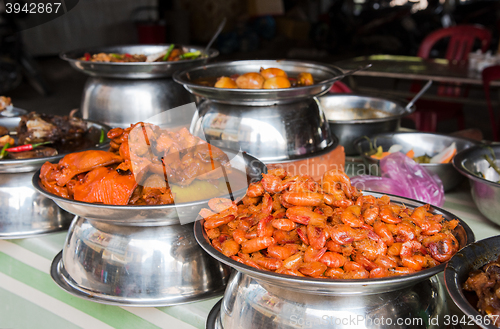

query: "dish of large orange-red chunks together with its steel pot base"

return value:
[33, 122, 266, 307]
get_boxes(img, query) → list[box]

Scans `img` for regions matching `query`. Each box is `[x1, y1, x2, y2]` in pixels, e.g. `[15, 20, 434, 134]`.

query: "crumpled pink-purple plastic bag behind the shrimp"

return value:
[351, 152, 444, 207]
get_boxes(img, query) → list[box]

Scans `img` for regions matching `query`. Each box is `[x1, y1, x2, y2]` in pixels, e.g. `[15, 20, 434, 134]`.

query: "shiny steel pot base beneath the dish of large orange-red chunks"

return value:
[51, 217, 230, 307]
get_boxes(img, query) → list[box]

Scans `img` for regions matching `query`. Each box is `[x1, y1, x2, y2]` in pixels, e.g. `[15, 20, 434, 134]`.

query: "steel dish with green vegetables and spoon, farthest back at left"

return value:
[60, 44, 219, 79]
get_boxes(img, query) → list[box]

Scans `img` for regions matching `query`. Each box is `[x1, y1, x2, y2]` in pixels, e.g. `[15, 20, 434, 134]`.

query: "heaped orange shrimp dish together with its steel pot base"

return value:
[194, 169, 474, 328]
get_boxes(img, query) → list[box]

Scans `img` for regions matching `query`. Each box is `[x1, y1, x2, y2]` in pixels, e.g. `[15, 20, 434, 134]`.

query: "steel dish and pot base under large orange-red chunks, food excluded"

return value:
[39, 151, 266, 307]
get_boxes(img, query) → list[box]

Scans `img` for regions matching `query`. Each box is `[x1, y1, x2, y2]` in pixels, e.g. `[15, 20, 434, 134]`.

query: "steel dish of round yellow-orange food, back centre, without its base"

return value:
[174, 60, 343, 105]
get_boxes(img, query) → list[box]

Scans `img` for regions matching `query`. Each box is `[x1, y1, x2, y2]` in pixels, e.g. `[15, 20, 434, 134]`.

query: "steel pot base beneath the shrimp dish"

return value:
[206, 272, 449, 329]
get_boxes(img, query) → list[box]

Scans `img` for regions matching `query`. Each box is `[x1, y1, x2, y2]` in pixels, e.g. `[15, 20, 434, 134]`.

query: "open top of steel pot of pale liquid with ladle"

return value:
[318, 94, 415, 124]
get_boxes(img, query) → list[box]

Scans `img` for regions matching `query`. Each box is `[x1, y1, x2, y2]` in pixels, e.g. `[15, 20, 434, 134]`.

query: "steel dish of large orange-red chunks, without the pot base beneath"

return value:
[33, 122, 266, 226]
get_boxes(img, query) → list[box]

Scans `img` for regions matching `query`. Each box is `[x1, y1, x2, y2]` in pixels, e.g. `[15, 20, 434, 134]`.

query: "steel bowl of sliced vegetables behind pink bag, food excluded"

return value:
[354, 132, 478, 191]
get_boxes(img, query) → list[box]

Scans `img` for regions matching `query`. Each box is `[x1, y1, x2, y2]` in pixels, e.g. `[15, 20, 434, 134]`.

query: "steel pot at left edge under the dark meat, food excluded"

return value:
[0, 117, 110, 239]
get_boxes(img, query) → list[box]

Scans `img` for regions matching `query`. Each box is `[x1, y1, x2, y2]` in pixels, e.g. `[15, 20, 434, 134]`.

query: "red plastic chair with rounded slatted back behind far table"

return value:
[409, 25, 491, 131]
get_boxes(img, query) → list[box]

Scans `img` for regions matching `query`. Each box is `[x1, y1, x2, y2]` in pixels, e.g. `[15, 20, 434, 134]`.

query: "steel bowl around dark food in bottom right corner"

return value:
[444, 236, 500, 329]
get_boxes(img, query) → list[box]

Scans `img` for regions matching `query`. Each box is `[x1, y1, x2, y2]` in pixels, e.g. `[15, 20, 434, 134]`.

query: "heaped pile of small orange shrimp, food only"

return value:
[200, 168, 459, 279]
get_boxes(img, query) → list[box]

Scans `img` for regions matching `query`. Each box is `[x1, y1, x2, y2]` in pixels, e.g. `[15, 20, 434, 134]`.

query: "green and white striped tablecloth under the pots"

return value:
[0, 182, 500, 329]
